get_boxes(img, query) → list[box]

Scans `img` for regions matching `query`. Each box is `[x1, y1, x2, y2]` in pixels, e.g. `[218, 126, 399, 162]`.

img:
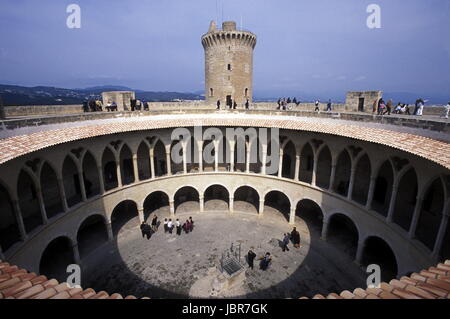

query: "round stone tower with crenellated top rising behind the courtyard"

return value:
[202, 21, 256, 108]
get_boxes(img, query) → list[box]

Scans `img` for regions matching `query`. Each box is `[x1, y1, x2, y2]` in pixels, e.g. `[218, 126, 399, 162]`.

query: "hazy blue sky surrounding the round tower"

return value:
[0, 0, 450, 96]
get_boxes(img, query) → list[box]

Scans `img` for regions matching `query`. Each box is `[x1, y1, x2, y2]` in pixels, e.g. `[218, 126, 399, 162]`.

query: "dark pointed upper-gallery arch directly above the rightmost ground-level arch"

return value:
[371, 160, 394, 217]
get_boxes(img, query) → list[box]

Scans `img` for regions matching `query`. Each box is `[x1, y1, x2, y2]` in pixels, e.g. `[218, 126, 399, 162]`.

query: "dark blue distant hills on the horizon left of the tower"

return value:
[0, 84, 204, 106]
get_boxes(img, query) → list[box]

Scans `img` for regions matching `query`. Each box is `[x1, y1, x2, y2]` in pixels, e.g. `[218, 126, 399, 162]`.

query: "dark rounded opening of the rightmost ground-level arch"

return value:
[361, 236, 398, 282]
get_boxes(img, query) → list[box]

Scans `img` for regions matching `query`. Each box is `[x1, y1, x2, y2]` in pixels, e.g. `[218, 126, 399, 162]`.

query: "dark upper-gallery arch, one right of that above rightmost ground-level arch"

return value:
[392, 167, 418, 231]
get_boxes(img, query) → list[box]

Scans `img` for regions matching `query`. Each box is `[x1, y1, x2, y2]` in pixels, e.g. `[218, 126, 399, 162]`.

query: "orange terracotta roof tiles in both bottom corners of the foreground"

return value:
[0, 260, 450, 299]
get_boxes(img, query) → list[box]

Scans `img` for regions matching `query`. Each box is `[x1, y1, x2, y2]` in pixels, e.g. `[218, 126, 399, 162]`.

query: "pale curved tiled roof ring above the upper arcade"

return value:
[0, 114, 450, 169]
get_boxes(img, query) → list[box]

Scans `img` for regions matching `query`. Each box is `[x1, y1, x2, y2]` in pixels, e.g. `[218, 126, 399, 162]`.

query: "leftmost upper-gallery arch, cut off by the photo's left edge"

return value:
[0, 182, 21, 251]
